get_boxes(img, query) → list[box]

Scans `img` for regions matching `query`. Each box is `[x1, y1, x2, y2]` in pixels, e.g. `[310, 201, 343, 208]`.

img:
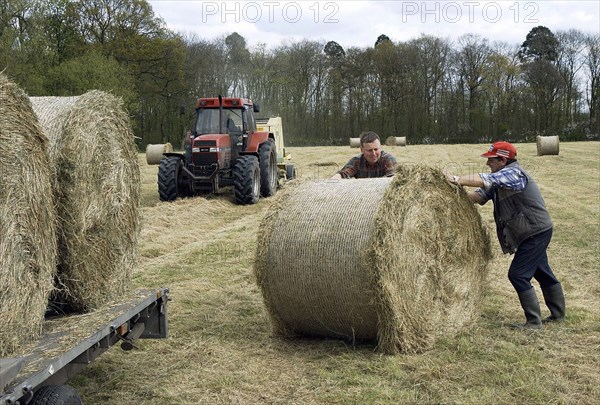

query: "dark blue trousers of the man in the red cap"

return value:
[508, 228, 558, 293]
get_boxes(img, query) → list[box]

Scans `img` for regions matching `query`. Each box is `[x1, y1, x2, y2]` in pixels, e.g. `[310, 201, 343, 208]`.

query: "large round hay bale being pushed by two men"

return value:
[254, 166, 491, 353]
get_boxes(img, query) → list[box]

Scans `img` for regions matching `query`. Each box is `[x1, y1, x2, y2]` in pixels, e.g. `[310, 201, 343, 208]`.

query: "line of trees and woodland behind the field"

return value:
[0, 0, 600, 150]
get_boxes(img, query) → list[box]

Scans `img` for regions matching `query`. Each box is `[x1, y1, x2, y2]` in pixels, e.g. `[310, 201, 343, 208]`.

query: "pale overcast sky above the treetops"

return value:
[149, 0, 600, 49]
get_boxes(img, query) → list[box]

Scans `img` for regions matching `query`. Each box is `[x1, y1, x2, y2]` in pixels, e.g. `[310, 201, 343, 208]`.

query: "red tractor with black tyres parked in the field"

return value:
[158, 96, 279, 204]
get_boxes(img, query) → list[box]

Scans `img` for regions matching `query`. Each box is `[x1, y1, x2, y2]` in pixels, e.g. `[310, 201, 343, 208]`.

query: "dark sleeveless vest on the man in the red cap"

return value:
[492, 162, 552, 253]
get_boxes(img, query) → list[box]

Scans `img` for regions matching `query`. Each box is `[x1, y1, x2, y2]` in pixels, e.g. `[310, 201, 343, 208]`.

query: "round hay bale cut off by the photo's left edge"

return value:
[0, 74, 57, 356]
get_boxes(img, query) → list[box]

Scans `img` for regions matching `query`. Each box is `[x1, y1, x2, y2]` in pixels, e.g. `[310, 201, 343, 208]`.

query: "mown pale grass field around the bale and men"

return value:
[72, 142, 600, 404]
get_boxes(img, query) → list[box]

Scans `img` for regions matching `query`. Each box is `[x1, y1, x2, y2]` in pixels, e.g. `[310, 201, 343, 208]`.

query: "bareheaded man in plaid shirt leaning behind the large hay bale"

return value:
[332, 131, 398, 179]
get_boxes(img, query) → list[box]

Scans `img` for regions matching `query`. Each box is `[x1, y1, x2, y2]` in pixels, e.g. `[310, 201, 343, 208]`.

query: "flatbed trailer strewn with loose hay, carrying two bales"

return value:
[0, 288, 169, 405]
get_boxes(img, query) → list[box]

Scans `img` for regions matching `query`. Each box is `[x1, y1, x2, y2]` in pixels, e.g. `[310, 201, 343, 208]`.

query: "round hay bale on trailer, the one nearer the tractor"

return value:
[31, 91, 140, 311]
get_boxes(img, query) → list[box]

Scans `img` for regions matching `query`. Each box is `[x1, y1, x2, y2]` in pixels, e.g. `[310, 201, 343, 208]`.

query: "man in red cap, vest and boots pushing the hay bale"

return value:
[446, 142, 565, 329]
